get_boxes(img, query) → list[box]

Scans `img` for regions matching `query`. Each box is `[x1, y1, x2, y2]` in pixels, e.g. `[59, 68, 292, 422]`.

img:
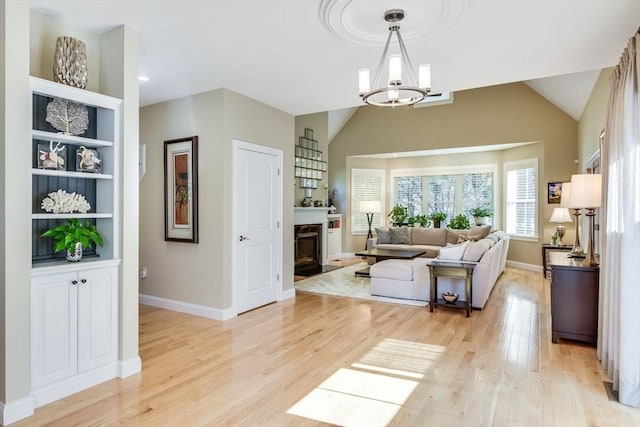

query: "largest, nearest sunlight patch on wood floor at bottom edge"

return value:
[287, 368, 418, 427]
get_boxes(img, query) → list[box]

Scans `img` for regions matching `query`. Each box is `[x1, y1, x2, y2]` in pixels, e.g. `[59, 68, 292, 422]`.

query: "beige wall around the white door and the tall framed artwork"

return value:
[140, 89, 294, 309]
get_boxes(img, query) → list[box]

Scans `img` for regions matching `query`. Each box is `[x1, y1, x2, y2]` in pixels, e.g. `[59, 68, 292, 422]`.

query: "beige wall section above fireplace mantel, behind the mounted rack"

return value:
[293, 112, 329, 206]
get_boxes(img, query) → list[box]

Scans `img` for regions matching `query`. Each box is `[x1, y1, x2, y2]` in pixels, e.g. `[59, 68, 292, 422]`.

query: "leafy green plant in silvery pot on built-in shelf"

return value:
[42, 218, 104, 262]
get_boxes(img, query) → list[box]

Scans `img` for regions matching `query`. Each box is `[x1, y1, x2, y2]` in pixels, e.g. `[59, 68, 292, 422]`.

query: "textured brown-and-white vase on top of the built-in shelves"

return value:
[53, 36, 87, 89]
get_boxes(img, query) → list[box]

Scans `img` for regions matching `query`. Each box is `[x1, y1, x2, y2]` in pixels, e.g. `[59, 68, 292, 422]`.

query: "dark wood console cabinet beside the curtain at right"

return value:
[549, 252, 600, 345]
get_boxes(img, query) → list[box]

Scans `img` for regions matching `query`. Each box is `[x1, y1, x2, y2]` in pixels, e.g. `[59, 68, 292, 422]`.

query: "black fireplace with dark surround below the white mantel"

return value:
[294, 224, 322, 276]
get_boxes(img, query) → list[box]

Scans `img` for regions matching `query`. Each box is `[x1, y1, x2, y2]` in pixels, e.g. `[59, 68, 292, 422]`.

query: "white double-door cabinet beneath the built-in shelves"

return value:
[31, 265, 118, 406]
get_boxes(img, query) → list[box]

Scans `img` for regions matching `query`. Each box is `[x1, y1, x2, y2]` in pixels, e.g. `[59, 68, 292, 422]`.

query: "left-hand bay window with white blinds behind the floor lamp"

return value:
[351, 169, 385, 234]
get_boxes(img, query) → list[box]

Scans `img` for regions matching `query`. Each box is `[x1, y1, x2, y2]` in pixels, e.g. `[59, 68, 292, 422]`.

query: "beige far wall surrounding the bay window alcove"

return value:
[329, 83, 577, 265]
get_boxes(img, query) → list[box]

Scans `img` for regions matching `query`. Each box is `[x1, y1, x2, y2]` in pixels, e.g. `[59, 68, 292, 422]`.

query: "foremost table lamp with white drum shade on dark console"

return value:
[571, 173, 602, 267]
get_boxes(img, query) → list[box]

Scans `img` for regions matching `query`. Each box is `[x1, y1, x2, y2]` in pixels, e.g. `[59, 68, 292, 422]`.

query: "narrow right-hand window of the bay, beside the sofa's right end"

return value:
[504, 159, 538, 238]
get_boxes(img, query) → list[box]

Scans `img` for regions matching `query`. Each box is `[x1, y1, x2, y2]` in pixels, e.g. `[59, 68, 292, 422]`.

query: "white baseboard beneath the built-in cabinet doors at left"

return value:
[31, 362, 118, 408]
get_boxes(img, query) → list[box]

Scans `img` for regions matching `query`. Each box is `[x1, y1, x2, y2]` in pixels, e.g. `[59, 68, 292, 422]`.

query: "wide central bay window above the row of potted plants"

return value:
[391, 165, 497, 227]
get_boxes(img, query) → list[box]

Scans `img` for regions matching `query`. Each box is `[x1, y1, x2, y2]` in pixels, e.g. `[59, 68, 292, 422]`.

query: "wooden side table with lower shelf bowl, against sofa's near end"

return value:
[427, 259, 476, 317]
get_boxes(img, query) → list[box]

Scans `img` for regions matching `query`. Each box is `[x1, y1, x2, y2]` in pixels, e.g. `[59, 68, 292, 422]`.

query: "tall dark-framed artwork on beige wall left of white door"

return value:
[164, 136, 198, 243]
